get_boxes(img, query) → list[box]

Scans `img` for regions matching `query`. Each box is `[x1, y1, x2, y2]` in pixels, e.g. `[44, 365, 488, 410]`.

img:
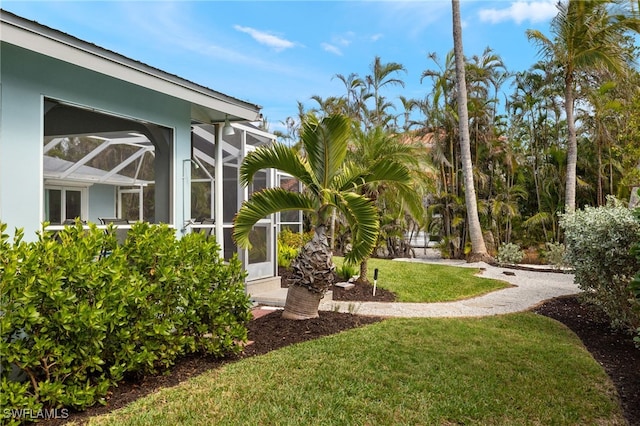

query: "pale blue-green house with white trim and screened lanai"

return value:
[0, 10, 301, 296]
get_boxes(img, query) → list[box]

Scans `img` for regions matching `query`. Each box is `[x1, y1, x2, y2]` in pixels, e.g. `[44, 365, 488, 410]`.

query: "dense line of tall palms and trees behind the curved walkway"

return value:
[268, 0, 640, 257]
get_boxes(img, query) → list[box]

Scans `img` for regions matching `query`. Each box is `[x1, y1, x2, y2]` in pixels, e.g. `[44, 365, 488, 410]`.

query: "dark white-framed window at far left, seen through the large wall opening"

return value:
[44, 187, 87, 225]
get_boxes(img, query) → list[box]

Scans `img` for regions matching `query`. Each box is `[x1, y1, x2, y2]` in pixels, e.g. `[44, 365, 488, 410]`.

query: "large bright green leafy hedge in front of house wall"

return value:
[0, 222, 250, 422]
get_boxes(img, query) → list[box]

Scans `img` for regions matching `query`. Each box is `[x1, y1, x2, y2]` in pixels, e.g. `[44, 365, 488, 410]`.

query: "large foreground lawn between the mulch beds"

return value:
[76, 313, 624, 426]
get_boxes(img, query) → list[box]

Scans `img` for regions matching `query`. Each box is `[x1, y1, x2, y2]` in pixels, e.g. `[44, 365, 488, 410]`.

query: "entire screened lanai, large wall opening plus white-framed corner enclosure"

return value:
[43, 105, 302, 279]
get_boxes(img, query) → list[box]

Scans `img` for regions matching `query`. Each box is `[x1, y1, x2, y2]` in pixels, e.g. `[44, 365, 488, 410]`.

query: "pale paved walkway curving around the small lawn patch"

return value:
[320, 258, 580, 317]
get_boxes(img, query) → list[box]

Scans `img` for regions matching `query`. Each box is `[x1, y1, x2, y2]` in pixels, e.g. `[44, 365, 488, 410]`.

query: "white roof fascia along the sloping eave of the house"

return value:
[0, 11, 260, 121]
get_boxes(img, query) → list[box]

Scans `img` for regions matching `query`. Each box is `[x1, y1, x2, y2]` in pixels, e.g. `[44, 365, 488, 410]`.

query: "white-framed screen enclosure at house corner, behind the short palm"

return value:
[187, 123, 302, 278]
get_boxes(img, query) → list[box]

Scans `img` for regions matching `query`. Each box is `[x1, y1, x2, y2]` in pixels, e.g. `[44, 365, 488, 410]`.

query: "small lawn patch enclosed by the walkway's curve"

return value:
[334, 257, 511, 303]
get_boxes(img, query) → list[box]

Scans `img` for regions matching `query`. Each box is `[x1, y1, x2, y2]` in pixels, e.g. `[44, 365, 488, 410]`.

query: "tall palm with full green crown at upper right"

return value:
[527, 0, 637, 213]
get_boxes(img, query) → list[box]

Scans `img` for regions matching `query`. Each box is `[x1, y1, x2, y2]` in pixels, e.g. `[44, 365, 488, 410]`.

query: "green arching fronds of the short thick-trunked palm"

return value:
[233, 114, 380, 270]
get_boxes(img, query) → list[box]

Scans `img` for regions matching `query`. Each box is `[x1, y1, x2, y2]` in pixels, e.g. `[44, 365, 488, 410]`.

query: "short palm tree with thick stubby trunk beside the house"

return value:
[233, 114, 409, 319]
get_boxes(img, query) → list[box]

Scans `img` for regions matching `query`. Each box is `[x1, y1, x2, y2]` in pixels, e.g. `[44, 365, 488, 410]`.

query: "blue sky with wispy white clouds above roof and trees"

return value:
[0, 0, 557, 131]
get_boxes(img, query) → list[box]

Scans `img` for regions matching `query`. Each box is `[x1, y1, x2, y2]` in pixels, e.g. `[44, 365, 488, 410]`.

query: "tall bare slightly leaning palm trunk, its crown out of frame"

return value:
[451, 0, 491, 262]
